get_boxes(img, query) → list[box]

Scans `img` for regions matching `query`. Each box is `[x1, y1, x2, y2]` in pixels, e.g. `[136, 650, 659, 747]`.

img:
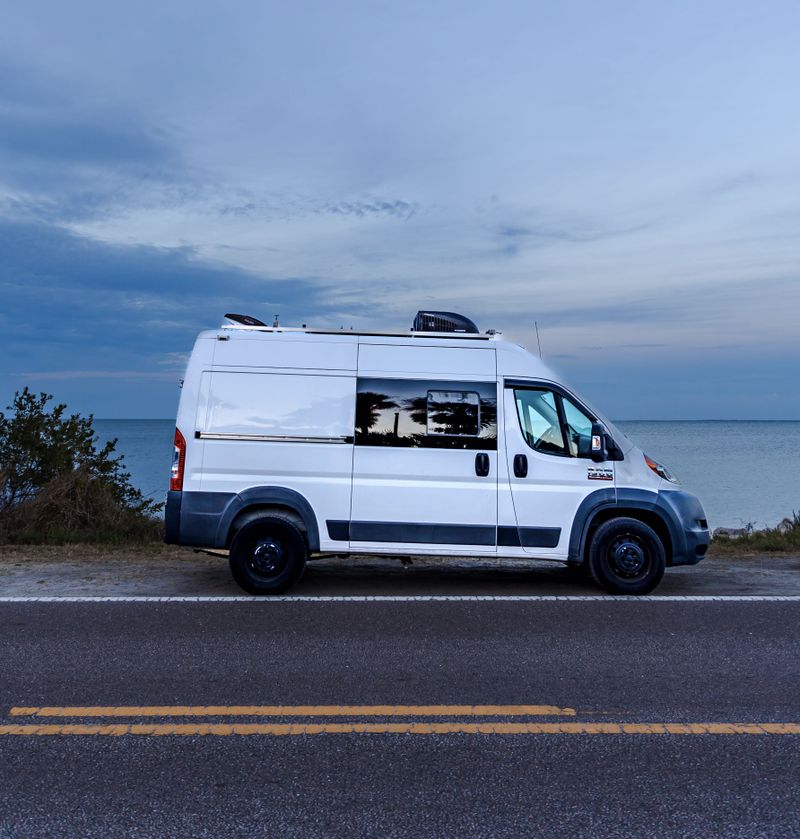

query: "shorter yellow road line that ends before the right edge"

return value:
[10, 705, 575, 717]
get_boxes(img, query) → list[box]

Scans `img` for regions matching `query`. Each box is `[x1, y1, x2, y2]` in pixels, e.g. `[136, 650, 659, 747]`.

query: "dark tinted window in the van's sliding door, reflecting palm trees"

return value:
[355, 379, 497, 450]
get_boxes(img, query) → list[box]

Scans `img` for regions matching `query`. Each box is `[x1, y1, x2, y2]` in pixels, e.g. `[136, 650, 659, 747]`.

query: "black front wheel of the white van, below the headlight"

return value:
[589, 518, 667, 595]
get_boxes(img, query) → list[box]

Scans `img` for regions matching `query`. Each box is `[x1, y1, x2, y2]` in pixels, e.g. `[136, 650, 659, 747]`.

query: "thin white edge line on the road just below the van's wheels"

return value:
[0, 594, 800, 604]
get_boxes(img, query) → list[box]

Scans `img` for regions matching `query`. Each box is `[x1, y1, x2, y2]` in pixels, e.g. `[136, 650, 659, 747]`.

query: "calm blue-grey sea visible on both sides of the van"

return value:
[95, 420, 800, 527]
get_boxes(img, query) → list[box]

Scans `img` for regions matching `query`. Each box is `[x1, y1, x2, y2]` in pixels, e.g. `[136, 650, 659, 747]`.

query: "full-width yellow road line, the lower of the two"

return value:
[0, 722, 800, 737]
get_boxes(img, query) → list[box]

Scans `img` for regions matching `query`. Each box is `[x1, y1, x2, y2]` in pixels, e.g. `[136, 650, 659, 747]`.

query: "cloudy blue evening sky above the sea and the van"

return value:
[0, 0, 800, 419]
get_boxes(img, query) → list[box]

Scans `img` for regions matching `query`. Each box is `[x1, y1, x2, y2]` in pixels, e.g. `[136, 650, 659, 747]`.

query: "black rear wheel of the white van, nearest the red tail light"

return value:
[230, 516, 308, 594]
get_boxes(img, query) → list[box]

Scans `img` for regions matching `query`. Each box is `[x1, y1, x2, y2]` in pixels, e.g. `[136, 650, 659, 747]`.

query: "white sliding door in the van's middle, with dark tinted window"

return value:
[348, 345, 498, 554]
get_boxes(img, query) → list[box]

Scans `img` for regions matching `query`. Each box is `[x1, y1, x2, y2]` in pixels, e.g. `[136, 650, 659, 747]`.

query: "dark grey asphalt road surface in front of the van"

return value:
[0, 600, 800, 838]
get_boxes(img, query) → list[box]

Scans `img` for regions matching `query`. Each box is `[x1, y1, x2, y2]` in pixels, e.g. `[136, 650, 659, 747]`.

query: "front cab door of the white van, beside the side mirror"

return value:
[501, 381, 614, 559]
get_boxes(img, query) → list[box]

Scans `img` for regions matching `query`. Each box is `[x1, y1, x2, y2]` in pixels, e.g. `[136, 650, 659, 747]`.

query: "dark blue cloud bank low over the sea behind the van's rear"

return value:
[0, 221, 352, 400]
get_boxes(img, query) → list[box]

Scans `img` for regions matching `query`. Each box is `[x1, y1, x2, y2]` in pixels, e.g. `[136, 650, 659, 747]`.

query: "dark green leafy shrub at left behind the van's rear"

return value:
[0, 388, 161, 544]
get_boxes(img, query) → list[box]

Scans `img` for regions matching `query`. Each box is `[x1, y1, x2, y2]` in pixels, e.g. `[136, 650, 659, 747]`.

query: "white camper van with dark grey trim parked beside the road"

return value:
[166, 312, 709, 594]
